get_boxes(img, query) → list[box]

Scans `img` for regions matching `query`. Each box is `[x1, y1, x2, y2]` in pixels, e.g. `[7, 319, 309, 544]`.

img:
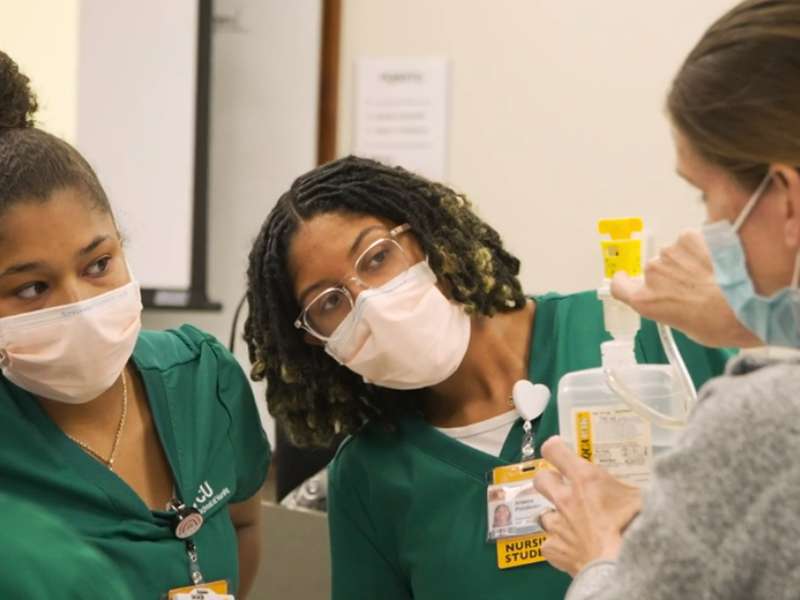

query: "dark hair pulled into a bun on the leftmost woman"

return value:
[0, 52, 111, 213]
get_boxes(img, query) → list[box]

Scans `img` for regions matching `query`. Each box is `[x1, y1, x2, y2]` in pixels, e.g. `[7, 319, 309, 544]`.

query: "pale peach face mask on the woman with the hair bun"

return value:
[0, 281, 142, 404]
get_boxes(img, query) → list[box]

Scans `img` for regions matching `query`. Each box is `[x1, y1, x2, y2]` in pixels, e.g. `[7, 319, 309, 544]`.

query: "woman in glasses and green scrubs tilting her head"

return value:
[245, 157, 727, 600]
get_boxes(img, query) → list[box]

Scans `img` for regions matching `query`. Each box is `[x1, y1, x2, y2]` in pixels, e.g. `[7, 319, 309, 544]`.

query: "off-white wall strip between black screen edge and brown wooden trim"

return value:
[143, 0, 321, 440]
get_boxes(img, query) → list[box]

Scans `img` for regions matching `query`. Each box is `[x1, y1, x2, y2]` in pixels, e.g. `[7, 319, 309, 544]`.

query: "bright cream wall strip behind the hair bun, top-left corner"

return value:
[0, 0, 78, 141]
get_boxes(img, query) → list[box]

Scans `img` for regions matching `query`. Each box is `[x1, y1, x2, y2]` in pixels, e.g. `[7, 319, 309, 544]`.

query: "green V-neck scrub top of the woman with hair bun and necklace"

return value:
[0, 325, 270, 600]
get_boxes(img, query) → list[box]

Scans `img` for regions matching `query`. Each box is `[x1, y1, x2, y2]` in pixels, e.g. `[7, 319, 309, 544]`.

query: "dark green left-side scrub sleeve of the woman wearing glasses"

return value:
[328, 454, 413, 600]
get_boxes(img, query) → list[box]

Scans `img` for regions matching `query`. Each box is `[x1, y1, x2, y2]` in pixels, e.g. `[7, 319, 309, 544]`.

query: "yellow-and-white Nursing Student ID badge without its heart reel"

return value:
[486, 458, 554, 569]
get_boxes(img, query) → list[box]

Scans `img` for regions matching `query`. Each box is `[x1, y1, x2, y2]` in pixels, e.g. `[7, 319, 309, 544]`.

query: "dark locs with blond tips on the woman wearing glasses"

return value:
[244, 156, 526, 446]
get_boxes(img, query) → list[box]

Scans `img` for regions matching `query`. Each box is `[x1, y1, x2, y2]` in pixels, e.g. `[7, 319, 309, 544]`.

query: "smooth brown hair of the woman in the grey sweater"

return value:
[667, 0, 800, 189]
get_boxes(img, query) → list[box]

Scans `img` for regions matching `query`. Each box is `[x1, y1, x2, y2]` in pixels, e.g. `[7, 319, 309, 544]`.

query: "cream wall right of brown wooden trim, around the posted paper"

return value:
[338, 0, 733, 292]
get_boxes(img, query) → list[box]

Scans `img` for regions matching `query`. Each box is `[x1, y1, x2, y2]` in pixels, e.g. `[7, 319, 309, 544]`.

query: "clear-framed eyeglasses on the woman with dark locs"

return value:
[294, 223, 411, 342]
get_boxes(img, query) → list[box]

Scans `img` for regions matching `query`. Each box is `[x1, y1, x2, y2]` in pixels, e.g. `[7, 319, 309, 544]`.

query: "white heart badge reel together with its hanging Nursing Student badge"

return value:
[486, 380, 552, 569]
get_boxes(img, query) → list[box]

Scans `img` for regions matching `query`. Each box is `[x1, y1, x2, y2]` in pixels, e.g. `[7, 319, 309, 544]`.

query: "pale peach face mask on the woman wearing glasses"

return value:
[325, 262, 471, 390]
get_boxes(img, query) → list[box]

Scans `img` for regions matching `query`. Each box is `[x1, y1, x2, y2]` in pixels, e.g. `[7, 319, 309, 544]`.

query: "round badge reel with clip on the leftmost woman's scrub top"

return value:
[166, 500, 235, 600]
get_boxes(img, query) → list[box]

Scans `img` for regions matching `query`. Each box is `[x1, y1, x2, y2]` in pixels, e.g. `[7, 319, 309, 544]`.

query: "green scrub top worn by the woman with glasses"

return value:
[328, 292, 730, 600]
